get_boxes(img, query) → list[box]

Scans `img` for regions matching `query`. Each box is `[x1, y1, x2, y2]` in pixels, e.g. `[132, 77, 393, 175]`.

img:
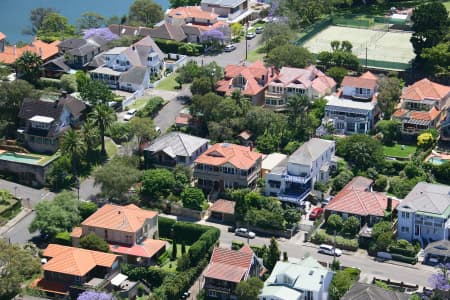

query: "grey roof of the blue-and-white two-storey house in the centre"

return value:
[288, 138, 335, 165]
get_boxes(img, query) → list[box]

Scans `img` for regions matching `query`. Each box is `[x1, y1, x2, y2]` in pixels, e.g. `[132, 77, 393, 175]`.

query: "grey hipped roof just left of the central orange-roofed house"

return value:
[145, 132, 209, 157]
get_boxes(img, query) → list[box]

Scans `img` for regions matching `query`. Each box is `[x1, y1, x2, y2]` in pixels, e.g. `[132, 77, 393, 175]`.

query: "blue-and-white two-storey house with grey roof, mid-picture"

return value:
[265, 138, 336, 205]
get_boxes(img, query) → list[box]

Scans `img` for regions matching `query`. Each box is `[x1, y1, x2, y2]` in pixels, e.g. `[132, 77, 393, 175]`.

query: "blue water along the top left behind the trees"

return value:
[0, 0, 169, 43]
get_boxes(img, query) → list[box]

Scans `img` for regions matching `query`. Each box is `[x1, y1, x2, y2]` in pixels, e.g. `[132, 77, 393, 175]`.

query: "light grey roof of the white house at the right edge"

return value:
[397, 182, 450, 216]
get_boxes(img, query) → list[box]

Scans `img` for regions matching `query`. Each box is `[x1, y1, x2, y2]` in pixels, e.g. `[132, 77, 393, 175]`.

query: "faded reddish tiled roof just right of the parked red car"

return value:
[325, 176, 399, 216]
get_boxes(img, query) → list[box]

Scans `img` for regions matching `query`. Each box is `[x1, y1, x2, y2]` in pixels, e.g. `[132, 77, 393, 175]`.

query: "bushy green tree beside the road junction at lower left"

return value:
[29, 192, 81, 237]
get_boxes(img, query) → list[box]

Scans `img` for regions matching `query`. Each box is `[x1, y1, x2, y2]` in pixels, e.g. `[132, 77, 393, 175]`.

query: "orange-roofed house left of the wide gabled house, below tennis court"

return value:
[216, 60, 277, 105]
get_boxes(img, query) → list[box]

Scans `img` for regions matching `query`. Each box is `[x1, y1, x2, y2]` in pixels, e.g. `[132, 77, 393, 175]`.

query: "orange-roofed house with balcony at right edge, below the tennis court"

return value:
[392, 78, 450, 137]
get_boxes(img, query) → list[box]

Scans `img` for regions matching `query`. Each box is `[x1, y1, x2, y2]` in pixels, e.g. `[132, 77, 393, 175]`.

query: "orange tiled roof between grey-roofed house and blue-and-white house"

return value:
[195, 143, 262, 170]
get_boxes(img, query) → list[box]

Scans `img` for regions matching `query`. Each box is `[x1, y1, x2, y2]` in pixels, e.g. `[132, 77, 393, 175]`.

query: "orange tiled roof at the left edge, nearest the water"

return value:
[0, 39, 60, 64]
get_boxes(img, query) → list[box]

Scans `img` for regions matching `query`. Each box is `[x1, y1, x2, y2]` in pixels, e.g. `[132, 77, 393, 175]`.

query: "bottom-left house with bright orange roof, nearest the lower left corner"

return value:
[32, 244, 120, 299]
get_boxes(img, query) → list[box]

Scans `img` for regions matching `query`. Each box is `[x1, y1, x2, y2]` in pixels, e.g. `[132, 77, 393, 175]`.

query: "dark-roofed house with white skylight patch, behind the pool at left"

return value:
[18, 93, 86, 154]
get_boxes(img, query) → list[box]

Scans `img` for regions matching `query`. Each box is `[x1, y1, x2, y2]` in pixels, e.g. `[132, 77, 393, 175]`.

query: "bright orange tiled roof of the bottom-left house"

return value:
[43, 244, 119, 276]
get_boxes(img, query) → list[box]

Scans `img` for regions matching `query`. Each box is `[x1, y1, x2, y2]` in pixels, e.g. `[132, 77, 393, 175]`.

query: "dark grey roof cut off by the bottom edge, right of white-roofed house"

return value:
[342, 282, 409, 300]
